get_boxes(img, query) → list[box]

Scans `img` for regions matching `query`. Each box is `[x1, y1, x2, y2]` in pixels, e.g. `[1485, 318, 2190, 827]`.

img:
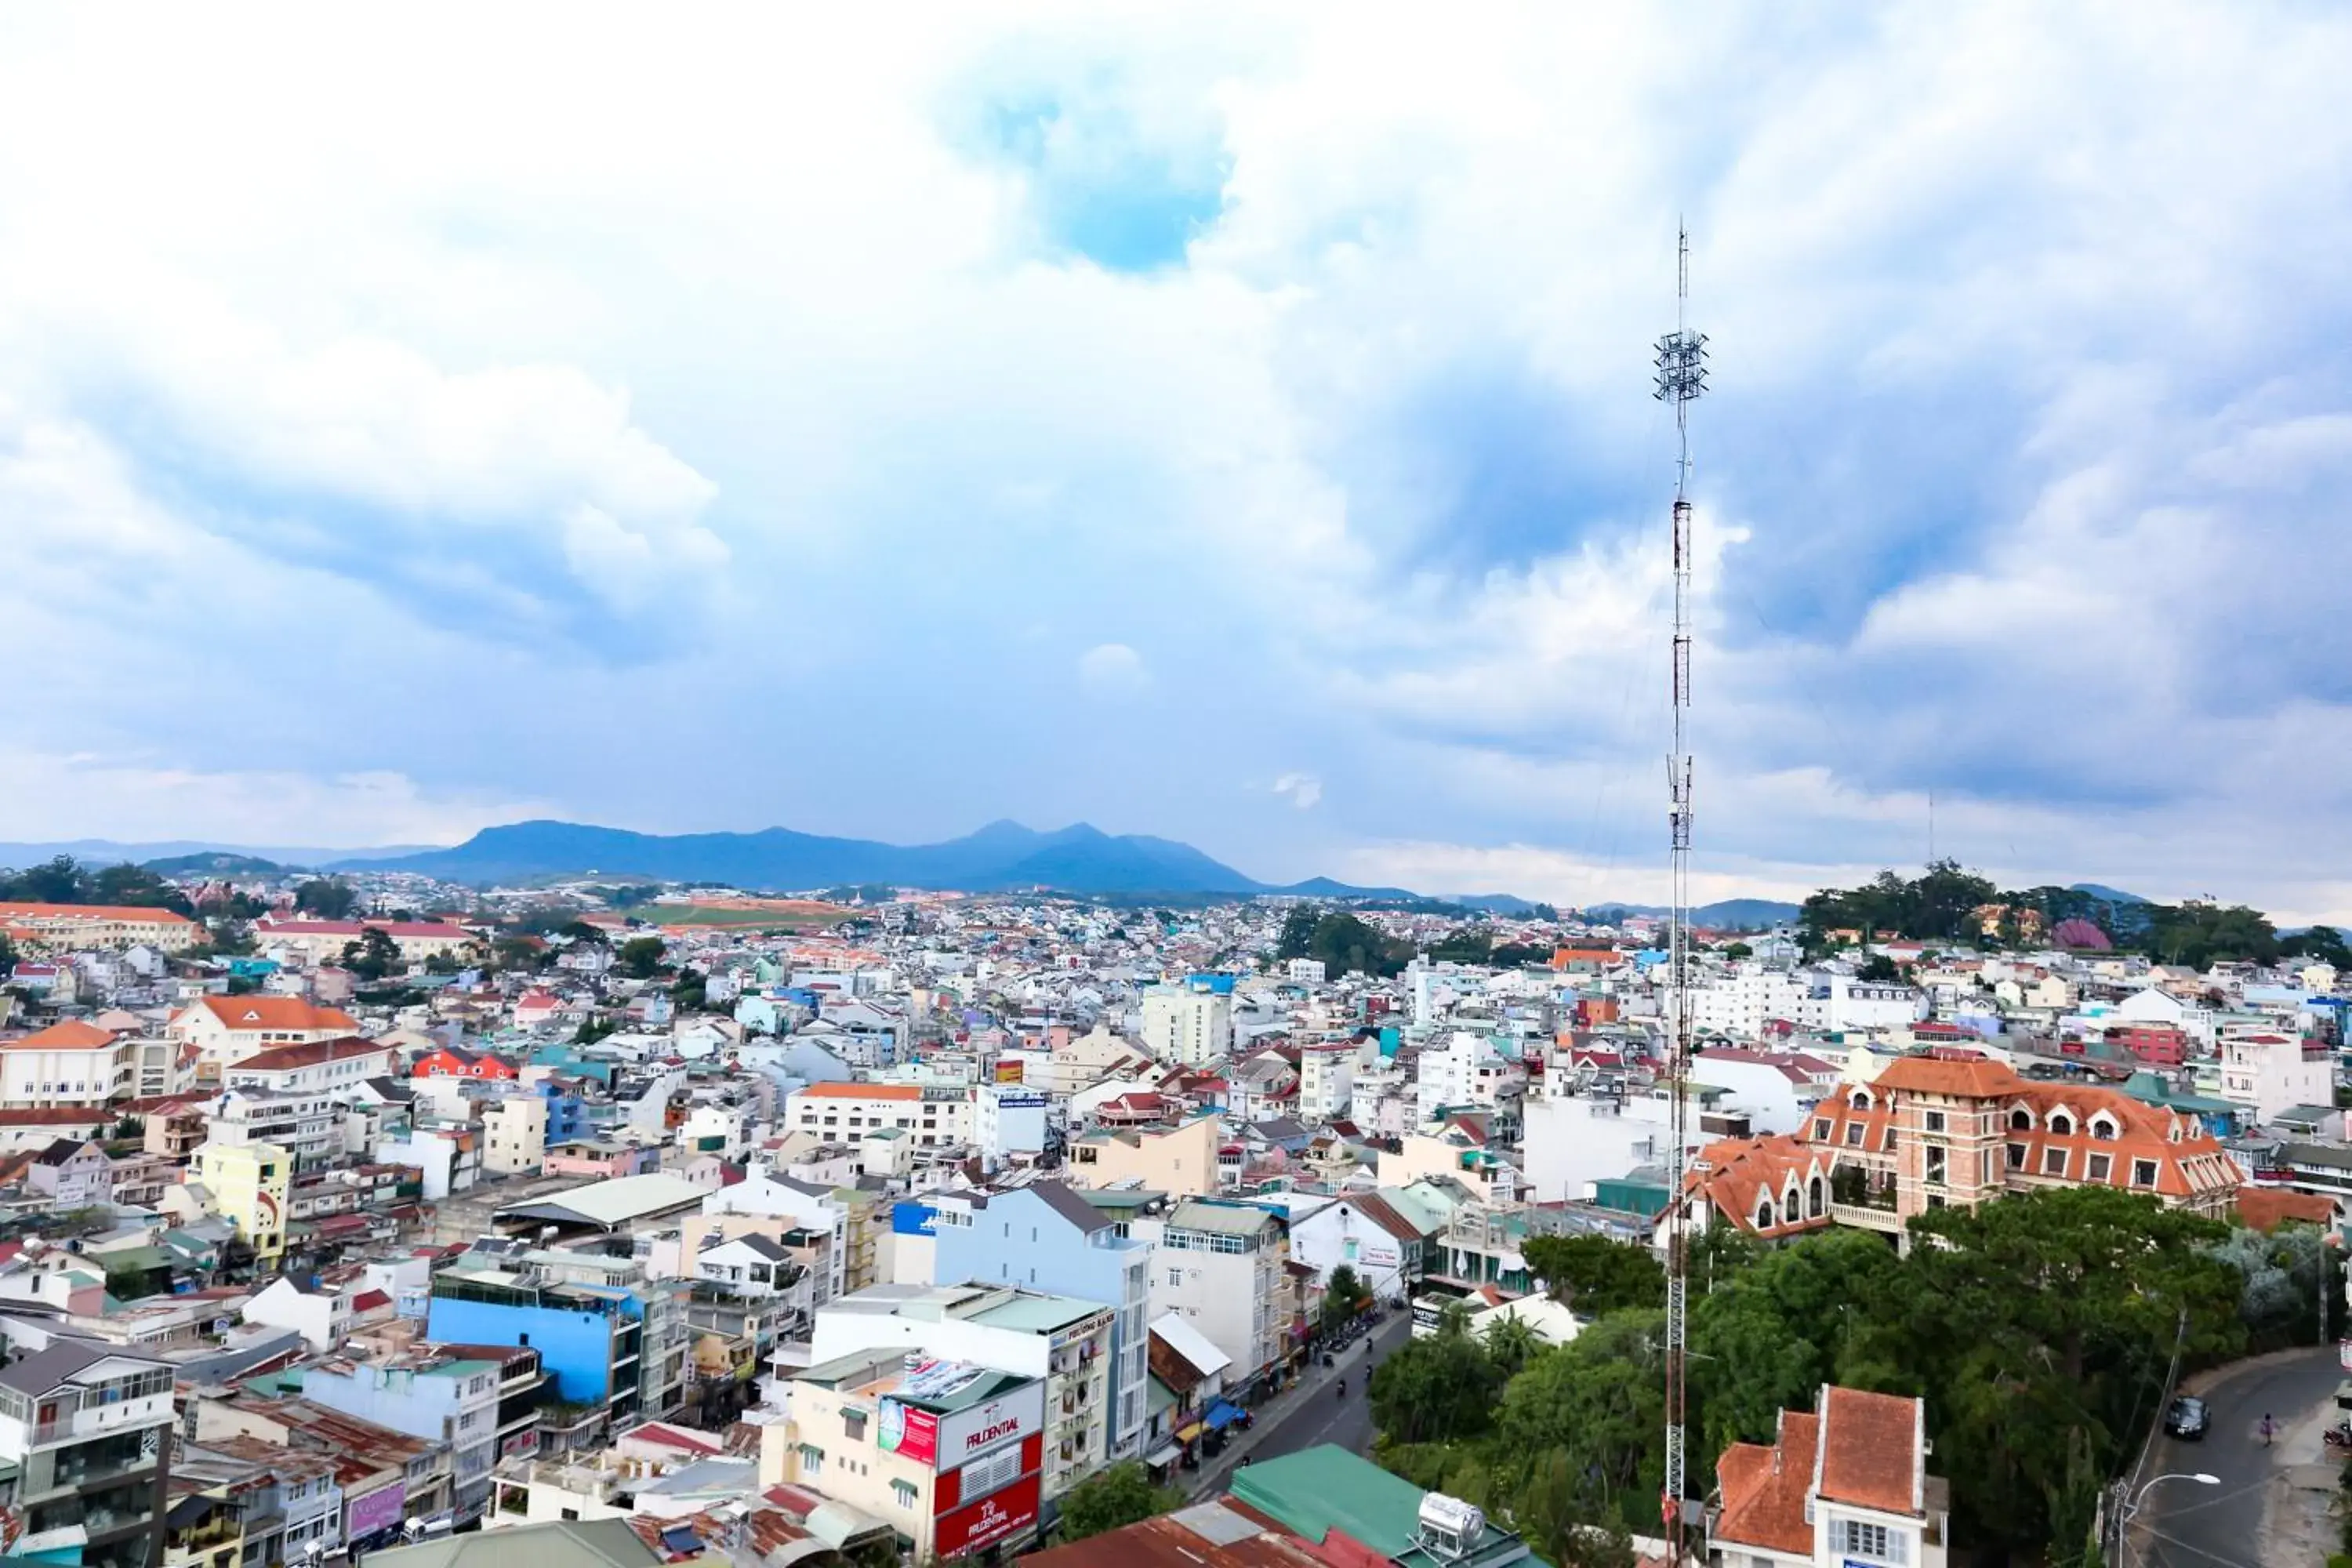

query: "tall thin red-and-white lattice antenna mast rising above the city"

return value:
[1658, 217, 1708, 1568]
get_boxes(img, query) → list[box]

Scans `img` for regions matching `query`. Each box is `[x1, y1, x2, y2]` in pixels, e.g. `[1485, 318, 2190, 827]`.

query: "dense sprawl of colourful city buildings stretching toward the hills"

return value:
[0, 869, 2352, 1568]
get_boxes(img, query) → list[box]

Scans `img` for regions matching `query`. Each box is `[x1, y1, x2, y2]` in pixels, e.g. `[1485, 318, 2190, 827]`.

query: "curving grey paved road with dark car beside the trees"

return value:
[2129, 1347, 2345, 1568]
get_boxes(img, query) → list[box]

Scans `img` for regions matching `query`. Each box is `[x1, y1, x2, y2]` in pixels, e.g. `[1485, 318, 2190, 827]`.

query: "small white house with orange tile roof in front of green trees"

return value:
[1708, 1385, 1950, 1568]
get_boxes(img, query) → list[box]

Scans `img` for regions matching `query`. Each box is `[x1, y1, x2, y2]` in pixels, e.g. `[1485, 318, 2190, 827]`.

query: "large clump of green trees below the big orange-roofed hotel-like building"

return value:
[1371, 1187, 2267, 1563]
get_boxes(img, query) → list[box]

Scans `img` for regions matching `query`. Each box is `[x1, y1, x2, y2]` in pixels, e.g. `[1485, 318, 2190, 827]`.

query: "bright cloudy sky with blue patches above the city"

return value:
[0, 0, 2352, 919]
